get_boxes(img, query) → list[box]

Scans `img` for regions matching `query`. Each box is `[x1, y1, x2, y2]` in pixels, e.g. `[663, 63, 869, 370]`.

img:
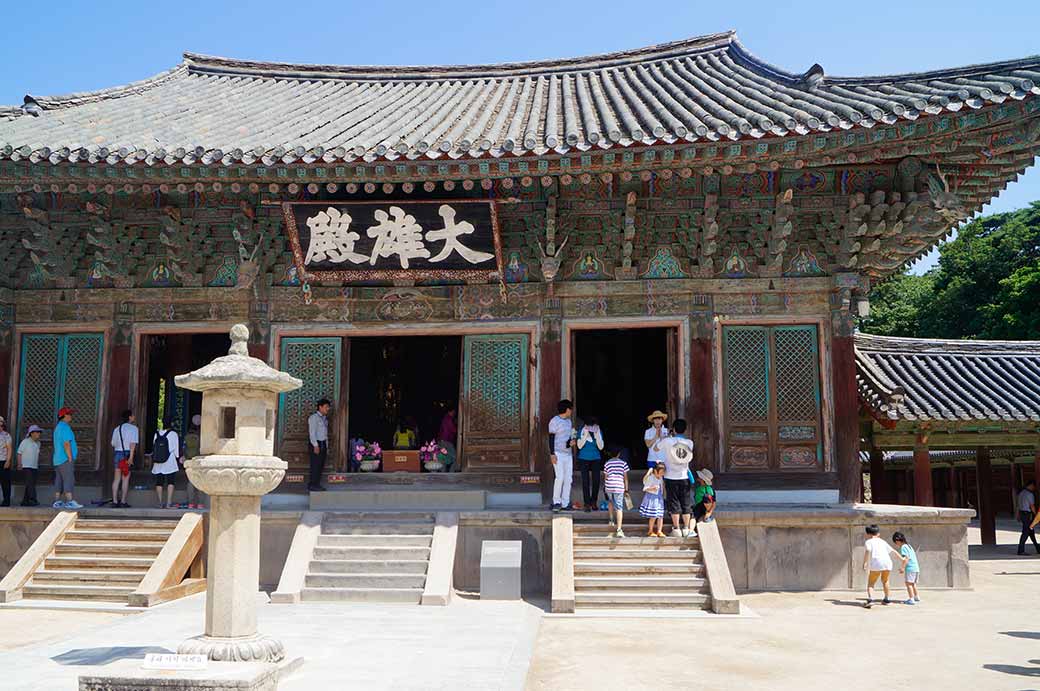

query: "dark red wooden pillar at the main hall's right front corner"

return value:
[831, 336, 863, 502]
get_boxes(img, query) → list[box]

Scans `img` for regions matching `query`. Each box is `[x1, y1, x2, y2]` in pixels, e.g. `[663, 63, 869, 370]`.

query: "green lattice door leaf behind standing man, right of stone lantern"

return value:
[278, 338, 343, 472]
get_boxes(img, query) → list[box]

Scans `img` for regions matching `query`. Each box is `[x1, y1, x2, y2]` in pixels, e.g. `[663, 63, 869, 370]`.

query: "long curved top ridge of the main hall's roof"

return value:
[184, 30, 736, 79]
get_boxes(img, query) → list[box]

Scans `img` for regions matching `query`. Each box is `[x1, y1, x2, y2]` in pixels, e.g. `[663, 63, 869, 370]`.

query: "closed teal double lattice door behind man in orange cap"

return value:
[17, 333, 105, 469]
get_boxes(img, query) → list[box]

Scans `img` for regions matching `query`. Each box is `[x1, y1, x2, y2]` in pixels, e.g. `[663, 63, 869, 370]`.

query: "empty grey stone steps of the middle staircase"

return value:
[300, 513, 434, 604]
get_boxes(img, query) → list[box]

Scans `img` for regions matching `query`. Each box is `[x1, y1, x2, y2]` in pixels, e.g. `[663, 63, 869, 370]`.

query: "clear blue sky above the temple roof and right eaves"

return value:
[0, 0, 1040, 272]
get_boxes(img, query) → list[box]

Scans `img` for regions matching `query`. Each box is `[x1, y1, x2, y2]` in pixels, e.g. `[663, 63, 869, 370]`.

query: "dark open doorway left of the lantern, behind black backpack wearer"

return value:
[137, 332, 231, 454]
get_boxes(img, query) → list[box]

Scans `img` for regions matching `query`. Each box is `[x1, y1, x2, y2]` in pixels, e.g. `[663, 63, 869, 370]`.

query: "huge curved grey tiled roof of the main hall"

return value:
[0, 32, 1040, 164]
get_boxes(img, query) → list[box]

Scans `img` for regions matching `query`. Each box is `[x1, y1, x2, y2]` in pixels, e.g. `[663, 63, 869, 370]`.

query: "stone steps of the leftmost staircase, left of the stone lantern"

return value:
[22, 518, 178, 605]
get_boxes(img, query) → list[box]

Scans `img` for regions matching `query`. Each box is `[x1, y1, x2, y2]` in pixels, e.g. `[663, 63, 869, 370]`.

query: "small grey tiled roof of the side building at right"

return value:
[855, 334, 1040, 421]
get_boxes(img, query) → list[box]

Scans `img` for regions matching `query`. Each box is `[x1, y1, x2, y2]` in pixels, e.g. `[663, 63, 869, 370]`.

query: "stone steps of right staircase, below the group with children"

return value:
[573, 516, 711, 610]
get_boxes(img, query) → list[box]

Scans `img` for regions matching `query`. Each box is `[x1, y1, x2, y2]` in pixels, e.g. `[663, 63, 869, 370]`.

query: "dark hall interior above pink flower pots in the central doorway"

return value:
[348, 336, 462, 447]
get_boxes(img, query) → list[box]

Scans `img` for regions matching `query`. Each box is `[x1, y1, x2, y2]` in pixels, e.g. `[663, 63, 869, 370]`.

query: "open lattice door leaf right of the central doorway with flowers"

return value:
[461, 334, 528, 470]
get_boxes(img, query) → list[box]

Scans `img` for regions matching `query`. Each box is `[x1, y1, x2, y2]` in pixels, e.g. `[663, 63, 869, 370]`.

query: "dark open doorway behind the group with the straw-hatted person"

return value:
[571, 328, 677, 467]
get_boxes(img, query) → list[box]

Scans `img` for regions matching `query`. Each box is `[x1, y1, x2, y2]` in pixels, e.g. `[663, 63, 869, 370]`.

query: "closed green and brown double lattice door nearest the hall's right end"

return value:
[723, 325, 824, 470]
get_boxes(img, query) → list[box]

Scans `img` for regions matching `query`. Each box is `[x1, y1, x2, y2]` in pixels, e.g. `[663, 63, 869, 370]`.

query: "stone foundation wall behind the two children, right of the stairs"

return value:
[717, 504, 974, 591]
